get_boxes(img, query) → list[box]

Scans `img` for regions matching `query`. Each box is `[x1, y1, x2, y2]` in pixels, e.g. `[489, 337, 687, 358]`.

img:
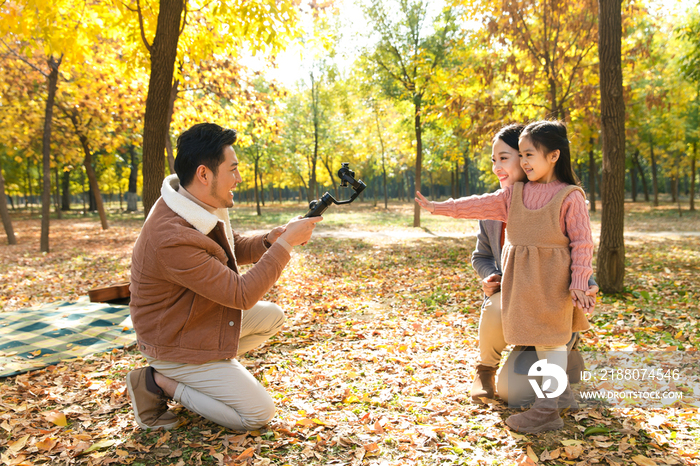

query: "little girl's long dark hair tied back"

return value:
[520, 120, 581, 186]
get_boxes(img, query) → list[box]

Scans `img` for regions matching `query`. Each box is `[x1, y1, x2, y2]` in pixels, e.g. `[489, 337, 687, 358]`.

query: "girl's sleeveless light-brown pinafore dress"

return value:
[501, 183, 590, 346]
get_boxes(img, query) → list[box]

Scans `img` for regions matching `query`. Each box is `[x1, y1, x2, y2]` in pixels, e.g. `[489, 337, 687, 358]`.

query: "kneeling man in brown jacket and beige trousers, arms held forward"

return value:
[127, 123, 322, 430]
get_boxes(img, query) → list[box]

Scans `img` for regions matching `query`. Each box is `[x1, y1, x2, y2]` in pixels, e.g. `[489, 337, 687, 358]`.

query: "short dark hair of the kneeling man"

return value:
[175, 123, 238, 187]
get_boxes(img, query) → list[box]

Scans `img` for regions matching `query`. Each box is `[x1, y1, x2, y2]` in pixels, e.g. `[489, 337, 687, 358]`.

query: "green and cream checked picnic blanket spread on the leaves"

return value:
[0, 296, 136, 377]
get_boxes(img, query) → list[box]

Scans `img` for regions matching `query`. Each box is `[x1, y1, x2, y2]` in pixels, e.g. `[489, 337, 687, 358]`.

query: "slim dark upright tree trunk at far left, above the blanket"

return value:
[39, 56, 63, 252]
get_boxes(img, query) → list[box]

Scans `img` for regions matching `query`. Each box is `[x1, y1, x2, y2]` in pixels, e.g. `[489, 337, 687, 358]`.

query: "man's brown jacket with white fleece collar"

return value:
[130, 175, 290, 364]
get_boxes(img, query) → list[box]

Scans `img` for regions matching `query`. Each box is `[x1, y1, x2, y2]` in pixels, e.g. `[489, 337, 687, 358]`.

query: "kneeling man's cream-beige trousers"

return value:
[146, 301, 284, 431]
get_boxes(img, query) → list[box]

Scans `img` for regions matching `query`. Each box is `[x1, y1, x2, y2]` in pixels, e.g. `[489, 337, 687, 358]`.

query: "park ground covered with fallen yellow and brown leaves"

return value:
[0, 205, 700, 466]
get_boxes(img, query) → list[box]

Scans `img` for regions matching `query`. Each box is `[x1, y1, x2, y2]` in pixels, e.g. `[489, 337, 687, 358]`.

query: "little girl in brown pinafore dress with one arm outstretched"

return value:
[416, 121, 595, 433]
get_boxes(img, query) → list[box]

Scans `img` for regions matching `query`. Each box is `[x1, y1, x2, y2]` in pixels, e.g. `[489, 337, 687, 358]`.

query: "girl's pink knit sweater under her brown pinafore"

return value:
[433, 181, 593, 291]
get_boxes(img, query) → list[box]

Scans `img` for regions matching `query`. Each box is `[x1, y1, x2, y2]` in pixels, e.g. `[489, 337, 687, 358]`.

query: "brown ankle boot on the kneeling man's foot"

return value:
[126, 366, 177, 430]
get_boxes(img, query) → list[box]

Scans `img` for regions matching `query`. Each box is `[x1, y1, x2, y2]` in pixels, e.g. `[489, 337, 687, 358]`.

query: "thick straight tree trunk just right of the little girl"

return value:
[596, 0, 625, 293]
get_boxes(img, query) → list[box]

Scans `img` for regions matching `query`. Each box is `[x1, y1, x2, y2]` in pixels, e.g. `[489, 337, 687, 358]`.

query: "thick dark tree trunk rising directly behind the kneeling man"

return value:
[143, 0, 184, 217]
